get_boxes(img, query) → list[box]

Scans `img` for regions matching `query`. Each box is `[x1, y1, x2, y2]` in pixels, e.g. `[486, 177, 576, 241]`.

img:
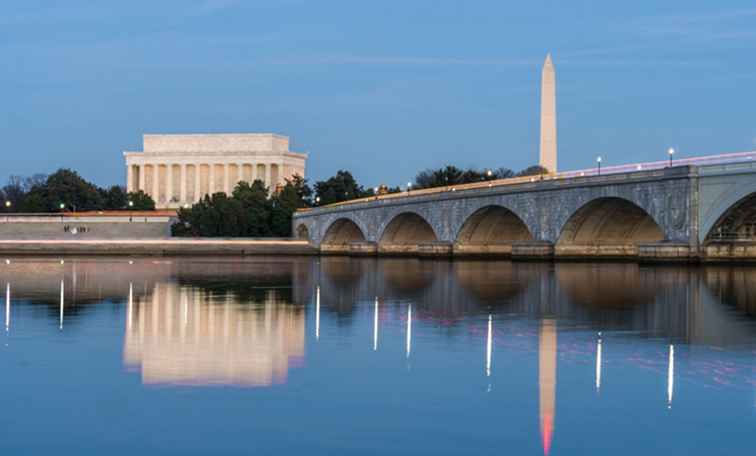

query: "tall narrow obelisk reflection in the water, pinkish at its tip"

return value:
[538, 319, 557, 455]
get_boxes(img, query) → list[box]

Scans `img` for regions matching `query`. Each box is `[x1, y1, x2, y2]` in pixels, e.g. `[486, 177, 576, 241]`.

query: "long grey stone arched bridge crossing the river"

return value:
[292, 161, 756, 260]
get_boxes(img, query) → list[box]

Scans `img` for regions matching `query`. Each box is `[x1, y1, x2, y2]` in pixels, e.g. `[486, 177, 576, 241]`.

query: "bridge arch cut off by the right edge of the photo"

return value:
[700, 188, 756, 241]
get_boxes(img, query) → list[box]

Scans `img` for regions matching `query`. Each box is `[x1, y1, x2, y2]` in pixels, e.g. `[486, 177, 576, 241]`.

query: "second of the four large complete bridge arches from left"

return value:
[377, 211, 439, 253]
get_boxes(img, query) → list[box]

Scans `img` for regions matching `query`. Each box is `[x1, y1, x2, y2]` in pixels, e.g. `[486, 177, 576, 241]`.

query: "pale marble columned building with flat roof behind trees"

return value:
[123, 133, 307, 208]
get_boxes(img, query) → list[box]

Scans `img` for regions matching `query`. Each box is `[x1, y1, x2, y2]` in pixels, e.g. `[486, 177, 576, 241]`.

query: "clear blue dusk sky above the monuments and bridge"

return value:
[0, 0, 756, 186]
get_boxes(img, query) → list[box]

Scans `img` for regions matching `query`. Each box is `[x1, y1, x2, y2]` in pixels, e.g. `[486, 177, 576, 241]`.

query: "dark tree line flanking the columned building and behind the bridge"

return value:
[0, 165, 547, 237]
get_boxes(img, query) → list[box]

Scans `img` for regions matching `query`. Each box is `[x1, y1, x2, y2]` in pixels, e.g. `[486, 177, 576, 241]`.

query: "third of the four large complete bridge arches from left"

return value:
[454, 204, 534, 253]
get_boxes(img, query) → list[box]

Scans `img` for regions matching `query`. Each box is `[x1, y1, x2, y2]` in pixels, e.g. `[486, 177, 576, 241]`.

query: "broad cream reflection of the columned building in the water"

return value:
[124, 282, 305, 387]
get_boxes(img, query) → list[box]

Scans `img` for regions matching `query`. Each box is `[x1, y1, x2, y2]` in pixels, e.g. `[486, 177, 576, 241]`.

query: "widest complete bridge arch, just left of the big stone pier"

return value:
[556, 197, 665, 255]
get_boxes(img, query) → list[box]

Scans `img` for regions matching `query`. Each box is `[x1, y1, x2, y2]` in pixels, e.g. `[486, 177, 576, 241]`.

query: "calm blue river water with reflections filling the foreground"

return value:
[0, 257, 756, 455]
